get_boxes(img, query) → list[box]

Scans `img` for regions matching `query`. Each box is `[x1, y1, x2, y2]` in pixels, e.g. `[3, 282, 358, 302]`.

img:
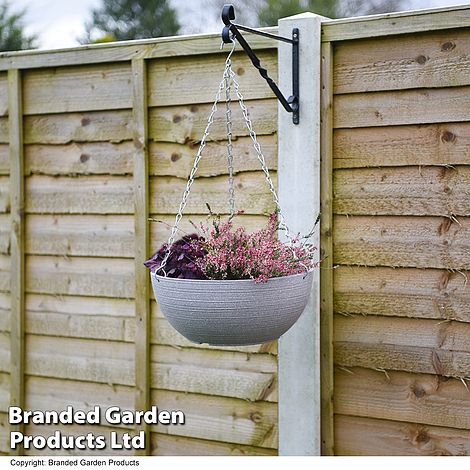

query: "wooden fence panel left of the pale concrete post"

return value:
[0, 30, 277, 455]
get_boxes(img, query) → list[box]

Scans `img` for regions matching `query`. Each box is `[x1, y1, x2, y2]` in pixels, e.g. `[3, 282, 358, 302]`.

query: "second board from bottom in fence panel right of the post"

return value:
[335, 368, 470, 429]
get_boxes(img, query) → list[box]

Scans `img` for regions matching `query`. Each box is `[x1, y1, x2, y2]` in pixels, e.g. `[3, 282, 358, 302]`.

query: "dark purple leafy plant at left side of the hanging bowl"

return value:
[144, 233, 206, 279]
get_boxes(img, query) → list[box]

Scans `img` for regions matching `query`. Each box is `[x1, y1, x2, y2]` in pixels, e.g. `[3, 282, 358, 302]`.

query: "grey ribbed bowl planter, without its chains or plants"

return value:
[151, 271, 313, 346]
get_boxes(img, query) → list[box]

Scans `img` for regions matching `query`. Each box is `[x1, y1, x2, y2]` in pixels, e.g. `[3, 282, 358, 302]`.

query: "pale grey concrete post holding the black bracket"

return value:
[278, 13, 322, 455]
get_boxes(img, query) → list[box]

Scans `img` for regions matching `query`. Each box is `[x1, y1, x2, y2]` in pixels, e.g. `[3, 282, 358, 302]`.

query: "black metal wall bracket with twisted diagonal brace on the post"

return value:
[222, 4, 300, 124]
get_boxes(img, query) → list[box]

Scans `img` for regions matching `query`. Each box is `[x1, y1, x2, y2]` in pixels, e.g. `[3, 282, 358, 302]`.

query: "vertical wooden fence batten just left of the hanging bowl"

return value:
[132, 59, 150, 455]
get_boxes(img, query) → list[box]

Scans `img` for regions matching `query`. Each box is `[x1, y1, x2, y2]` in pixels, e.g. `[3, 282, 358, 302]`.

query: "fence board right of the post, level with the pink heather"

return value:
[334, 216, 470, 270]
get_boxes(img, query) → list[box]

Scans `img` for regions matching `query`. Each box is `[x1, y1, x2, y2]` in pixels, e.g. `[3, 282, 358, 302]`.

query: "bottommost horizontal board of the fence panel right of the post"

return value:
[335, 415, 470, 456]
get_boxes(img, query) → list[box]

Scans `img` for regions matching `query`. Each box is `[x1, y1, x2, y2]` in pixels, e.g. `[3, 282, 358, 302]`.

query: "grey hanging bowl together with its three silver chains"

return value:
[151, 38, 313, 346]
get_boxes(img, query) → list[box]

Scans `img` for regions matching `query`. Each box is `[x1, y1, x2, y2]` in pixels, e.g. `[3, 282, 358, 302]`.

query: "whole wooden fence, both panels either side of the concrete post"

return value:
[0, 3, 470, 455]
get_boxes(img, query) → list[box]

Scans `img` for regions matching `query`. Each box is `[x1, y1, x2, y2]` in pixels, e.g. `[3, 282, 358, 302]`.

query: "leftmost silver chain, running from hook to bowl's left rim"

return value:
[156, 41, 236, 276]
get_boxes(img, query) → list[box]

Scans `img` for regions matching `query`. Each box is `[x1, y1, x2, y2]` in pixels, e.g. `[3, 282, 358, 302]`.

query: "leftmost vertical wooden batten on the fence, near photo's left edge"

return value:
[8, 69, 25, 455]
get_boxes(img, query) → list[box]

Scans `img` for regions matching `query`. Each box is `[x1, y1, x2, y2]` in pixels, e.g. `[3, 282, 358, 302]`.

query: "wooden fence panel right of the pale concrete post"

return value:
[324, 5, 470, 455]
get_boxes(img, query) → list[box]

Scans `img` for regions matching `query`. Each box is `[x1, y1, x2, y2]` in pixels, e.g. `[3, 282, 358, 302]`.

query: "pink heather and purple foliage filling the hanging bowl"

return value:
[146, 212, 316, 282]
